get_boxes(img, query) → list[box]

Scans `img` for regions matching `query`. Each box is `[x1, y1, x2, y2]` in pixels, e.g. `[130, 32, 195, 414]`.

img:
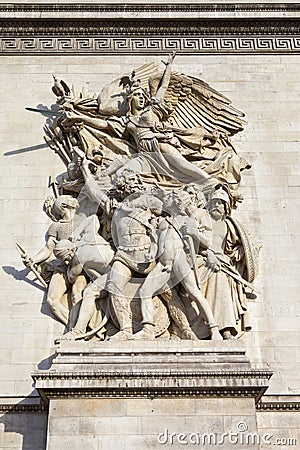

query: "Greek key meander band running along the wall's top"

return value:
[0, 36, 300, 54]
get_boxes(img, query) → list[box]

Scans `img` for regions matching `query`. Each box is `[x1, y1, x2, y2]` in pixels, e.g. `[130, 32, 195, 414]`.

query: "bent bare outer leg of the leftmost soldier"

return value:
[47, 273, 69, 325]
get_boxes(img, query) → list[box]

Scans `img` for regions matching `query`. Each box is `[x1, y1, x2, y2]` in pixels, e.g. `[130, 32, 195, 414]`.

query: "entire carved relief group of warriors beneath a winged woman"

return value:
[22, 54, 257, 340]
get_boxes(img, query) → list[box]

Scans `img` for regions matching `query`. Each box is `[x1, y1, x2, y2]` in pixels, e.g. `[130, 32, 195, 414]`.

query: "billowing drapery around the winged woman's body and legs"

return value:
[74, 103, 250, 189]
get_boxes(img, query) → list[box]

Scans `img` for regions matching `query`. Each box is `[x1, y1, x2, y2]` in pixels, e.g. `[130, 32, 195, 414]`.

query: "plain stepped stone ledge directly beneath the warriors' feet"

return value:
[44, 340, 250, 373]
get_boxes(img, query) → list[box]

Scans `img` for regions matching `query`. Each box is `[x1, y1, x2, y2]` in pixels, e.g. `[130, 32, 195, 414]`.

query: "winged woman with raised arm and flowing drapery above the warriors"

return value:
[45, 54, 250, 197]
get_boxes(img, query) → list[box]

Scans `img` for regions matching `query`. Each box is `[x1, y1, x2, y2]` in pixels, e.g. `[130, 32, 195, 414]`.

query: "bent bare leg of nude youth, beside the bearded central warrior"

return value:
[133, 262, 171, 339]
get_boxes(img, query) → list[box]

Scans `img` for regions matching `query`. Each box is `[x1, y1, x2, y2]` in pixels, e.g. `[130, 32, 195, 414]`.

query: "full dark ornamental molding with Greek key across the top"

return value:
[0, 3, 300, 55]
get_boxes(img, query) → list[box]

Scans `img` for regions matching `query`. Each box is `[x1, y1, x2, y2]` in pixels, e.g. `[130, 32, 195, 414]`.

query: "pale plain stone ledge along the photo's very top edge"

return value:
[0, 2, 300, 20]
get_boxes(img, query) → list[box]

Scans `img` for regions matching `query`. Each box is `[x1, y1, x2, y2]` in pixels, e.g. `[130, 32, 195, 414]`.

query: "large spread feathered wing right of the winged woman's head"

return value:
[165, 72, 246, 135]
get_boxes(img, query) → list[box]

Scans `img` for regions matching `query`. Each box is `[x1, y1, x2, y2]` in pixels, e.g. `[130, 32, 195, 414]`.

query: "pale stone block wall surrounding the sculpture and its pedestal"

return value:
[0, 2, 300, 450]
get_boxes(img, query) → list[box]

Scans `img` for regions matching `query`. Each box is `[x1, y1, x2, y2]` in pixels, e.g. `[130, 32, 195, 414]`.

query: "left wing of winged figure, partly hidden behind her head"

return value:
[98, 62, 157, 117]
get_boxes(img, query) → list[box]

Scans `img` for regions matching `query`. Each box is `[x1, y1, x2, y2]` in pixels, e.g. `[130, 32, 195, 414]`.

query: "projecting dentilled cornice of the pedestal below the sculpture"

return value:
[32, 369, 272, 402]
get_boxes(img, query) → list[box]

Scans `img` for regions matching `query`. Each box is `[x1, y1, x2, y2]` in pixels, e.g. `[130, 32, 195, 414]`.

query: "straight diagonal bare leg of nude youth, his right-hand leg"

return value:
[174, 258, 223, 340]
